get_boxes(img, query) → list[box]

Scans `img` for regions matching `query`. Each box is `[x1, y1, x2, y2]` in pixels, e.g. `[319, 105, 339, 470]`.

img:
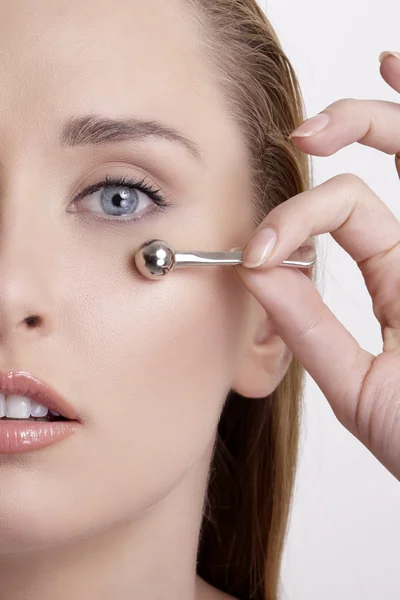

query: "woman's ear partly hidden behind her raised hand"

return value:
[231, 262, 312, 398]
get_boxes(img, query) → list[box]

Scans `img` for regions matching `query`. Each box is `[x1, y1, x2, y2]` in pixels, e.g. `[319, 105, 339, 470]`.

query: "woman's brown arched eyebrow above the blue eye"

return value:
[60, 115, 202, 160]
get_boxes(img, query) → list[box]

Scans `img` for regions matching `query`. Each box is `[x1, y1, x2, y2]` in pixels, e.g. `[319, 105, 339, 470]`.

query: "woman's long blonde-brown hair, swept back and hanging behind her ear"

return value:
[182, 0, 316, 600]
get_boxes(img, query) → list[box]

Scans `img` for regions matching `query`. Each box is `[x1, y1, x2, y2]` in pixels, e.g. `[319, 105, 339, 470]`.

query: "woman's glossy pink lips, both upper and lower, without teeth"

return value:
[0, 370, 81, 455]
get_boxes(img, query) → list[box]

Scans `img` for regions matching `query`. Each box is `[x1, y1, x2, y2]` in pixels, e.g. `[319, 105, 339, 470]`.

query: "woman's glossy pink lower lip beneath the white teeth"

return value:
[0, 419, 80, 454]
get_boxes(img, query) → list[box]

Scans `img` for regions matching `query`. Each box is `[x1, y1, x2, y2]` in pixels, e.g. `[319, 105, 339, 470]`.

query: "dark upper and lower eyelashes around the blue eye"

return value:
[73, 175, 170, 221]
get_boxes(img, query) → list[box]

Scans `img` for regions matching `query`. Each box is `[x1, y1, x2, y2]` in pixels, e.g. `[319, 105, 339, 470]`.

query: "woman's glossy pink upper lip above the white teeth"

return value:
[0, 369, 80, 421]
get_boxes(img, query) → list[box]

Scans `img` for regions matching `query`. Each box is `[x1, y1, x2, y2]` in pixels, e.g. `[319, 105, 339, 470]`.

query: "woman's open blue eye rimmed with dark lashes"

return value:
[69, 175, 169, 220]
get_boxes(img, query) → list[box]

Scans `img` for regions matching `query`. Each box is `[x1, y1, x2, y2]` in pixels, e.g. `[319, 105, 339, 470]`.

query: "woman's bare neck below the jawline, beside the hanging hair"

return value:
[0, 436, 216, 600]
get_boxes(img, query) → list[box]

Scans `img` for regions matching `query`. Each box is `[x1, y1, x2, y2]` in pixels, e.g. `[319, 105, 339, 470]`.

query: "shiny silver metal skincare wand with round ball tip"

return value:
[135, 240, 316, 279]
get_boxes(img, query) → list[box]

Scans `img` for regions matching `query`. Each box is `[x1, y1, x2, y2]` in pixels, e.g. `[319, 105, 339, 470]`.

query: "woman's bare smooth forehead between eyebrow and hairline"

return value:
[0, 0, 215, 140]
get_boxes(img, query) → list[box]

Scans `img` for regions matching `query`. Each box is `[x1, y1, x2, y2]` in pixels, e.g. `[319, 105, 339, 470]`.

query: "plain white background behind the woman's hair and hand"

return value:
[260, 0, 400, 600]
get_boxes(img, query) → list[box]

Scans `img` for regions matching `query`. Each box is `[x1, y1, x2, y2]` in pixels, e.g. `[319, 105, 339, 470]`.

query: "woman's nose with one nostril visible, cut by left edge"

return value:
[0, 191, 54, 346]
